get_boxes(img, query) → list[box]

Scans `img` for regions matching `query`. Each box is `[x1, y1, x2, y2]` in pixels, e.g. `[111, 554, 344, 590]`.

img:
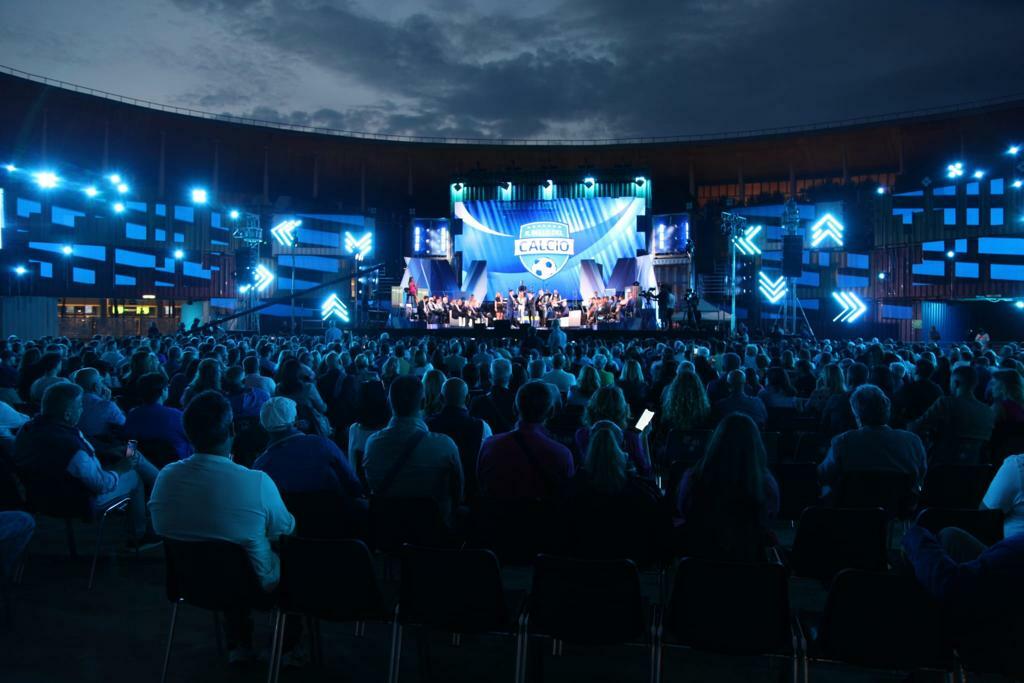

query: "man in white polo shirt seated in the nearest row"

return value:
[150, 390, 295, 663]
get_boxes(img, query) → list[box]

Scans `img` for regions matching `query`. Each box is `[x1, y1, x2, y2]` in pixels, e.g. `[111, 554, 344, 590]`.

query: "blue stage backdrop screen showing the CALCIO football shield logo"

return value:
[455, 197, 644, 300]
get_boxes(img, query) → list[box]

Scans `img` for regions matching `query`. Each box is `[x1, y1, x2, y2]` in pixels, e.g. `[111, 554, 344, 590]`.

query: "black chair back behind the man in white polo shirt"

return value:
[164, 539, 272, 610]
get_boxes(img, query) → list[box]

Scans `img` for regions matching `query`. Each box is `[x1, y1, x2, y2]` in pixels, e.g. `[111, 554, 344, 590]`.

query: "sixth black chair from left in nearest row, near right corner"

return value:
[802, 569, 953, 675]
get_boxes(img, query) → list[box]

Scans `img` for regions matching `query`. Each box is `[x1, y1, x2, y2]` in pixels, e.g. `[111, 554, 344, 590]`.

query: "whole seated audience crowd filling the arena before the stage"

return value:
[0, 330, 1024, 660]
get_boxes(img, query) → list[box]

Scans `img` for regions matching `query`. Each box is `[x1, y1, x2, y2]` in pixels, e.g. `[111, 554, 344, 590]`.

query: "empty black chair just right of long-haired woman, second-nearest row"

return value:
[790, 507, 888, 581]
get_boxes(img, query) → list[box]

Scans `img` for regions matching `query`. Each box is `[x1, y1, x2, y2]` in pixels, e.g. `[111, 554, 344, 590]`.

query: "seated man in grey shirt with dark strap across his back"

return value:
[362, 375, 463, 525]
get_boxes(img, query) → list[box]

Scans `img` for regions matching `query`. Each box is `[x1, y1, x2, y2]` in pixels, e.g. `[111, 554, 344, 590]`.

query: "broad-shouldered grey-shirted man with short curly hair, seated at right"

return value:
[818, 384, 928, 496]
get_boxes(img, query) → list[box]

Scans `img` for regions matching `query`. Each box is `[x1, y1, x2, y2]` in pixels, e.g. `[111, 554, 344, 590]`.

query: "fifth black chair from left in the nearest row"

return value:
[654, 558, 800, 681]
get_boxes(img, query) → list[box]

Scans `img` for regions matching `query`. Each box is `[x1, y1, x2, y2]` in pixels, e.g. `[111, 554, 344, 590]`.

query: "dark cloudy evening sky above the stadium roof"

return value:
[0, 0, 1024, 138]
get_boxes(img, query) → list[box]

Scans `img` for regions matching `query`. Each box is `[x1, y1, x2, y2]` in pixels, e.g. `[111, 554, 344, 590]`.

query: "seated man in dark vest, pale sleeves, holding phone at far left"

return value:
[14, 382, 157, 547]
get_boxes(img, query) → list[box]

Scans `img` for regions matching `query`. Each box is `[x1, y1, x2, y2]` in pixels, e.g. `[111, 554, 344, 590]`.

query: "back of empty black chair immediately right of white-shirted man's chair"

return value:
[278, 537, 386, 622]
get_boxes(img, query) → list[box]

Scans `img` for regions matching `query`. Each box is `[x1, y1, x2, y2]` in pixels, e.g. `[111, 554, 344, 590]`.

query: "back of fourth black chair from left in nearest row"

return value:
[528, 555, 646, 645]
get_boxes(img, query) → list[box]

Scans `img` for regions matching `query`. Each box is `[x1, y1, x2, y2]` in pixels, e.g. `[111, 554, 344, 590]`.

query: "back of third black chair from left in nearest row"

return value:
[398, 545, 512, 633]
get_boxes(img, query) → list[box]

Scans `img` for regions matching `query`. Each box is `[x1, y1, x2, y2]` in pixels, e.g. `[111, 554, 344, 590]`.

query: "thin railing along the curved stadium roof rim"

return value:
[6, 65, 1024, 146]
